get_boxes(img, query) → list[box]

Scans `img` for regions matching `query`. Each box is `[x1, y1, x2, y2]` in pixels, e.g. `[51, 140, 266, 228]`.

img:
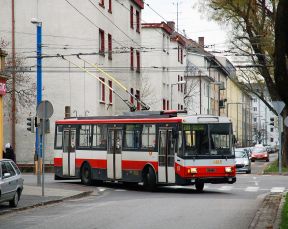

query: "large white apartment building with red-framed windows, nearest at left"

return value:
[0, 0, 144, 164]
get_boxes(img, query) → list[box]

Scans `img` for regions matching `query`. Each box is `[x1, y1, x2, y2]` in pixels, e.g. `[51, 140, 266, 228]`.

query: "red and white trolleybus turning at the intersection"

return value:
[54, 111, 236, 191]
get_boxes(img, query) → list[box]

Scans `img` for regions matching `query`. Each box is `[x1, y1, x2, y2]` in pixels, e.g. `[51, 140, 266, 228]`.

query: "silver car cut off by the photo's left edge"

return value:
[0, 159, 24, 207]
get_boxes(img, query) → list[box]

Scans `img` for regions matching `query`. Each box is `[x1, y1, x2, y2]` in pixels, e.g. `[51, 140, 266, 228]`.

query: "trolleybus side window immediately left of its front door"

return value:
[141, 124, 156, 149]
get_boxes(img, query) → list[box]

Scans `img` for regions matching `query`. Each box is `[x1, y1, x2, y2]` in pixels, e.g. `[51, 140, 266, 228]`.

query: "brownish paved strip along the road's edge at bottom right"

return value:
[248, 193, 284, 229]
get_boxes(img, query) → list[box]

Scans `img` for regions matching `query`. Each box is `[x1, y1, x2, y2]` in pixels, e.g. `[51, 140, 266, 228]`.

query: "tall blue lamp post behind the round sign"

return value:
[31, 18, 44, 185]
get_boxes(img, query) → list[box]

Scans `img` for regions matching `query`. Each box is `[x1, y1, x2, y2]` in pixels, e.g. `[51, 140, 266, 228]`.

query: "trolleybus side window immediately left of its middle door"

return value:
[92, 124, 107, 149]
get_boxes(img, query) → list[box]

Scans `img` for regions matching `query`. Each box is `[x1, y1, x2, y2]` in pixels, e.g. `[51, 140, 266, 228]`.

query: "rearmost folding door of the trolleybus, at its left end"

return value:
[62, 129, 76, 176]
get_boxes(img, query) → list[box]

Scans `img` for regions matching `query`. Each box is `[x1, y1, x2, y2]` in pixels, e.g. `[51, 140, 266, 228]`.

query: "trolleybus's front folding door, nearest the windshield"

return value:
[158, 129, 175, 183]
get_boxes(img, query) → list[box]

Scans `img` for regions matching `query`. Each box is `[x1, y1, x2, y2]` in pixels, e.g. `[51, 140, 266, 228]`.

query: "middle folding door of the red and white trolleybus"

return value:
[107, 129, 122, 179]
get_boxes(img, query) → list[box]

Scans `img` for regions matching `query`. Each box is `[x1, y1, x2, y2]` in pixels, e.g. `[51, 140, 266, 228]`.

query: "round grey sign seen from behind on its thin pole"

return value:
[37, 100, 53, 196]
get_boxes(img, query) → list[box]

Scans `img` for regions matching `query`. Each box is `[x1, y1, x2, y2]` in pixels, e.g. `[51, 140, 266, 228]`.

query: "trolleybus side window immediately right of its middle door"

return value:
[123, 124, 142, 149]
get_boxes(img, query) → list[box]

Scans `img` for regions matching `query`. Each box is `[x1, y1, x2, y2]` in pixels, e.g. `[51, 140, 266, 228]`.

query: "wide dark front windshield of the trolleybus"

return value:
[181, 123, 233, 156]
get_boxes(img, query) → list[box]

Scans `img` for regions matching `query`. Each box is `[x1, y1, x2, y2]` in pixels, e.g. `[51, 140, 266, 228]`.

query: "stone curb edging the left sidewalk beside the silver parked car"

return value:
[0, 191, 93, 216]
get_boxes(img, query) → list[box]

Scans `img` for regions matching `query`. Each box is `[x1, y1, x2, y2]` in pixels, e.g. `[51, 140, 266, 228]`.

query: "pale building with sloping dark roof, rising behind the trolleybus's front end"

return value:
[185, 37, 229, 115]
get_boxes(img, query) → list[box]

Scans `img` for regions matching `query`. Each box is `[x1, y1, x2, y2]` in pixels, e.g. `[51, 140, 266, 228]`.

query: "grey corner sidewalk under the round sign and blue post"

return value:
[0, 174, 95, 215]
